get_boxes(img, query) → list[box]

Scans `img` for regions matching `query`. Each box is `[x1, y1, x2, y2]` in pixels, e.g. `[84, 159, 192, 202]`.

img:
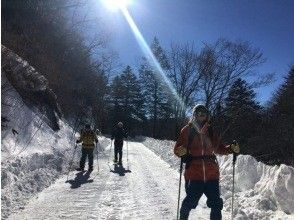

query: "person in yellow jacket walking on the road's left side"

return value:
[77, 124, 98, 172]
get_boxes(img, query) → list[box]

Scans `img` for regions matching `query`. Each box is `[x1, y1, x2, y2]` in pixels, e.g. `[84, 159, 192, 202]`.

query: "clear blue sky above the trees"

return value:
[94, 0, 294, 103]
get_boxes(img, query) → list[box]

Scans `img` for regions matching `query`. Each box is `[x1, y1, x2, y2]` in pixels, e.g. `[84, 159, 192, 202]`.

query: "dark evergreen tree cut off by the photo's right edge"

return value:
[262, 66, 294, 165]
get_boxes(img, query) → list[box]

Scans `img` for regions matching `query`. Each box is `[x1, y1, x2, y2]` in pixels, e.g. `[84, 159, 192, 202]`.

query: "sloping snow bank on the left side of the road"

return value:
[1, 47, 109, 219]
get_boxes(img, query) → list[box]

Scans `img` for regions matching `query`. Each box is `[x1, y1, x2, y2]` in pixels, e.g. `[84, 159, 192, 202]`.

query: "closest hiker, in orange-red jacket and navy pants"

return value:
[174, 104, 240, 220]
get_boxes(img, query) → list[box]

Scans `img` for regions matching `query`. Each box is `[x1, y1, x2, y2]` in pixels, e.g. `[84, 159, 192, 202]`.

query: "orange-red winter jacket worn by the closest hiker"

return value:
[174, 123, 232, 182]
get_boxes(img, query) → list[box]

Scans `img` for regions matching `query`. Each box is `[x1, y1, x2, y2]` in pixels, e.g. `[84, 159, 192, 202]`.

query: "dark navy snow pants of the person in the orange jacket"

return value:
[180, 180, 223, 220]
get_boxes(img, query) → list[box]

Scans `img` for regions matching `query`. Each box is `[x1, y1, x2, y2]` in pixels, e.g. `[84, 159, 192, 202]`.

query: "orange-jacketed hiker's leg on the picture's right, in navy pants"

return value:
[204, 180, 223, 220]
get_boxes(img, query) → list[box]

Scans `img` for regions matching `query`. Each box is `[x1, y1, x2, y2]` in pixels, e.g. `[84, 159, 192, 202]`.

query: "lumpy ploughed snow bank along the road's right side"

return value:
[141, 137, 294, 220]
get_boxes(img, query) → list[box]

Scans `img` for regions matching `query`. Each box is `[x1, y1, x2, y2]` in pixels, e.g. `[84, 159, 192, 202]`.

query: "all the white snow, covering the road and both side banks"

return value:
[1, 52, 294, 220]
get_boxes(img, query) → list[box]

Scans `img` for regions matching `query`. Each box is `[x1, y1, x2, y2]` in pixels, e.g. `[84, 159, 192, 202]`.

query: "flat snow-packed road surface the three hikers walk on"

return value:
[9, 142, 217, 220]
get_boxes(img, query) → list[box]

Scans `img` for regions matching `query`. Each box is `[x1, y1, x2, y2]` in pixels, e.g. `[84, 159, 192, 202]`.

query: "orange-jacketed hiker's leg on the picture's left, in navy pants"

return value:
[180, 180, 204, 220]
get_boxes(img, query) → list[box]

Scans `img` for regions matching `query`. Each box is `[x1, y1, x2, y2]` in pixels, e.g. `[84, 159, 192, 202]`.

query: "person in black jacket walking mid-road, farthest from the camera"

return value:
[111, 122, 127, 164]
